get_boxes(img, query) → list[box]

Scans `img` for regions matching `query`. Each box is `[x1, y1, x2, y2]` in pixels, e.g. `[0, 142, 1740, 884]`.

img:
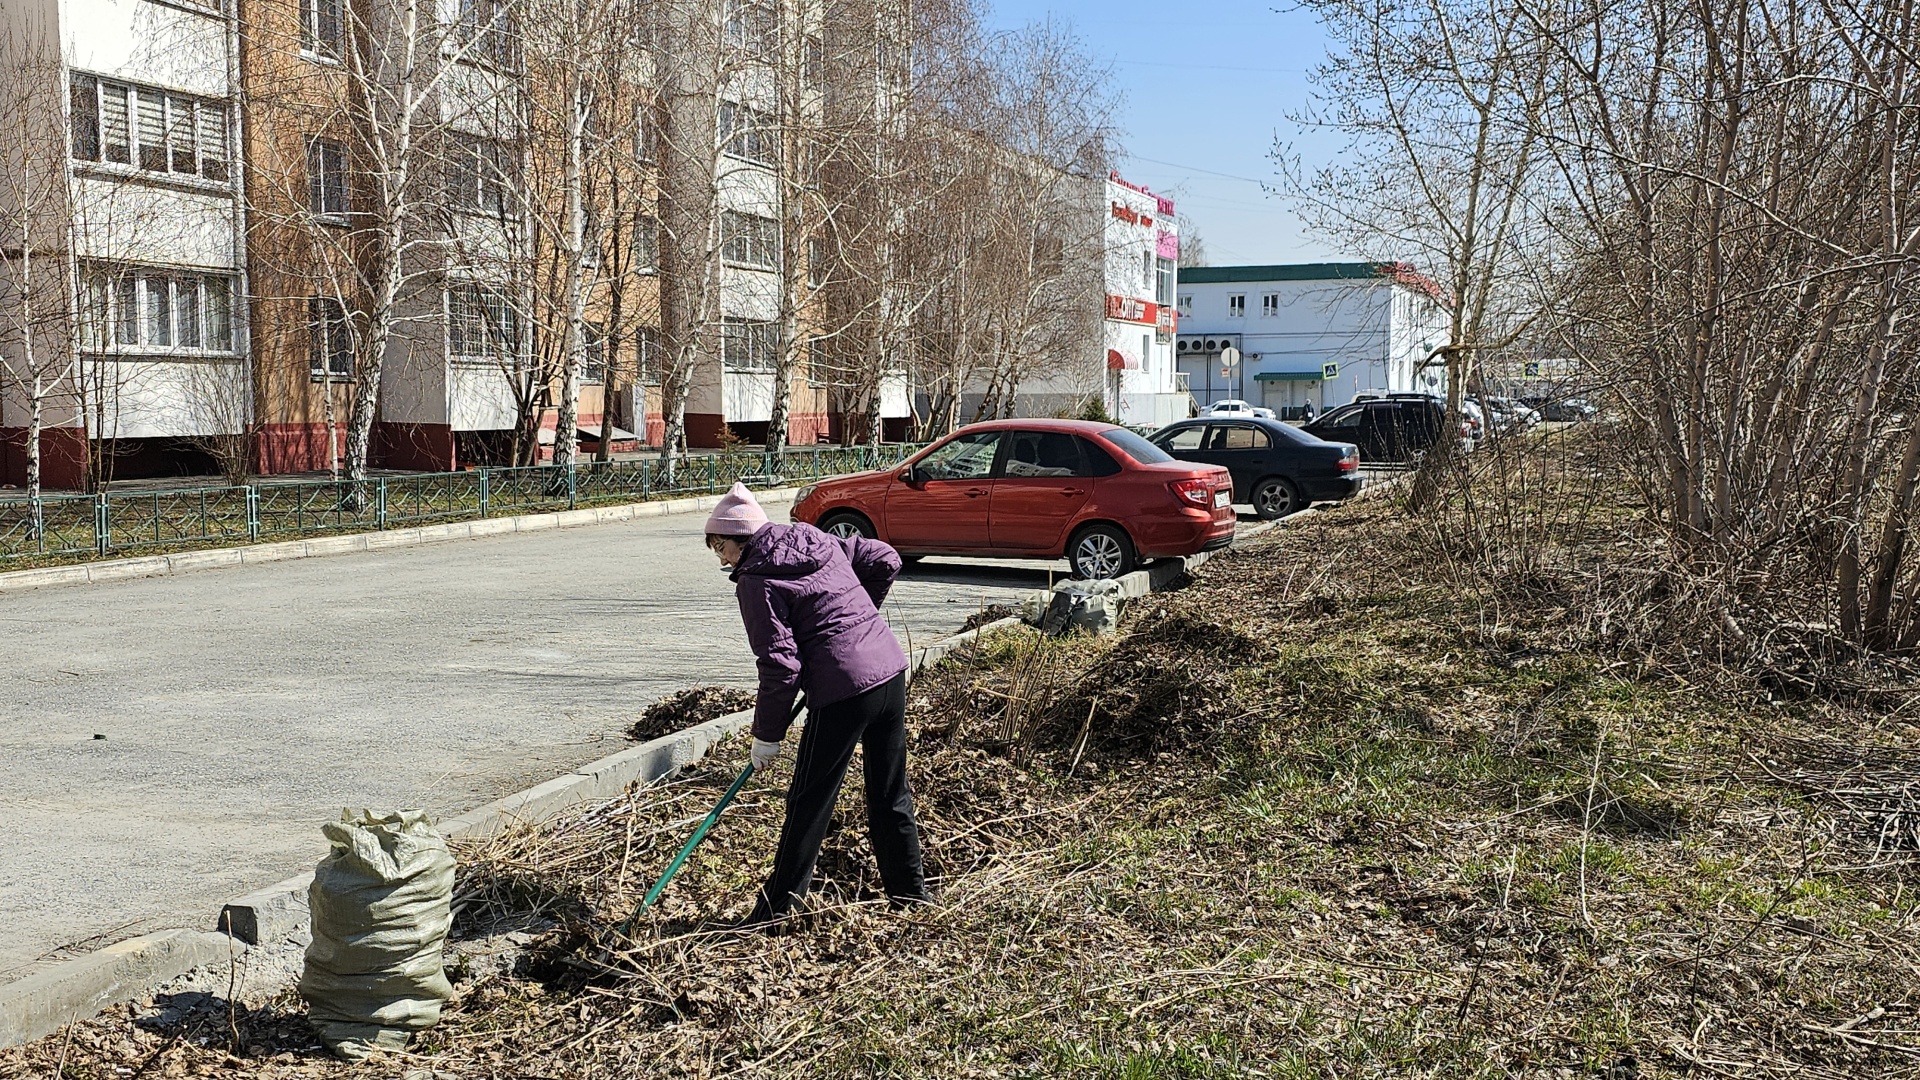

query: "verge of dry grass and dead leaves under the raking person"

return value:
[0, 438, 1920, 1078]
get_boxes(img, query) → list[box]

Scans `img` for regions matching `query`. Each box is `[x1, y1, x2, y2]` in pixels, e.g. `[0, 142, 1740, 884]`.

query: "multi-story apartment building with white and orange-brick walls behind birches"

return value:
[0, 0, 871, 488]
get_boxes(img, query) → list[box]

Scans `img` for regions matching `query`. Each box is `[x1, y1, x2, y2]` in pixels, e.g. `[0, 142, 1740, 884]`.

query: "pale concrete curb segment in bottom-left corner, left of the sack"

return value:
[0, 930, 246, 1045]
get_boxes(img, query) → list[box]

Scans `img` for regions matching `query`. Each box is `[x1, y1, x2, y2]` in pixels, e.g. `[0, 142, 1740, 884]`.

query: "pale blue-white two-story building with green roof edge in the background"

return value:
[1175, 263, 1448, 419]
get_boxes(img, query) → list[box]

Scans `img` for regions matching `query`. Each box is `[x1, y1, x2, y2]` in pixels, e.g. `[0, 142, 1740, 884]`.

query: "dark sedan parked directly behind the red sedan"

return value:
[1150, 417, 1361, 521]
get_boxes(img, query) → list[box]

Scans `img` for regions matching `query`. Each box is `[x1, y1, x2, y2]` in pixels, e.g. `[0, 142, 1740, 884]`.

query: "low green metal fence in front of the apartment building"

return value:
[0, 444, 920, 565]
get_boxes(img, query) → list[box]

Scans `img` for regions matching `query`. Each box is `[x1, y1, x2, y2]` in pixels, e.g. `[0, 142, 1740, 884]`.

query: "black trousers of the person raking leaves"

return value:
[755, 673, 927, 919]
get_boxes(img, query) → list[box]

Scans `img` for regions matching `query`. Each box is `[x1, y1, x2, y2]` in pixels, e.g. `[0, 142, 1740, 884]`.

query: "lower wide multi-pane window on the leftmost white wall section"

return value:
[79, 267, 234, 354]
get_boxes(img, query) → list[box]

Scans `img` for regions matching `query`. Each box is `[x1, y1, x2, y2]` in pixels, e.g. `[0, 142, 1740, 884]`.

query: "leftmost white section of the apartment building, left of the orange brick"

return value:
[0, 0, 252, 488]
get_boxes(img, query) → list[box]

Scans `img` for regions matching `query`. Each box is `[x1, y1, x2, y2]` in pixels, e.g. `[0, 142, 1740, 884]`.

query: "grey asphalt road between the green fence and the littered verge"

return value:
[0, 507, 1066, 982]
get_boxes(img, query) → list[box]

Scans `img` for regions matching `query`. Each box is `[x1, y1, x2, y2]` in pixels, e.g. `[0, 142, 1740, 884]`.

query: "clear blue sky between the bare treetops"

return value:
[993, 0, 1342, 265]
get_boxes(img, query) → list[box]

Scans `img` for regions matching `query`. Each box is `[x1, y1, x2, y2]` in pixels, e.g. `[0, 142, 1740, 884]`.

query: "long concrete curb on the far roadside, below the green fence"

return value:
[0, 488, 799, 592]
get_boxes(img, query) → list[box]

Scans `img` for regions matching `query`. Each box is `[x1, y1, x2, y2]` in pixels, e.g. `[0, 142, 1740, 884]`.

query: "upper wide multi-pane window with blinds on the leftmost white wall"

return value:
[69, 75, 230, 183]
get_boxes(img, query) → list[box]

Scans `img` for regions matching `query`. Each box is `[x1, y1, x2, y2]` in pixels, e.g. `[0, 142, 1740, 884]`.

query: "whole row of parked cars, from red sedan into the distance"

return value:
[793, 394, 1597, 578]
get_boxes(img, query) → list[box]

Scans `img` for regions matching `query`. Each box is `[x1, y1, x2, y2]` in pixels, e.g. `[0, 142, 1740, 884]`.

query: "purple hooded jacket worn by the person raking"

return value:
[733, 525, 906, 742]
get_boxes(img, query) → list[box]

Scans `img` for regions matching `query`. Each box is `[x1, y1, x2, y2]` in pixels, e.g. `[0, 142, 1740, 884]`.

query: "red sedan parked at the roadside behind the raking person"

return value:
[793, 419, 1235, 578]
